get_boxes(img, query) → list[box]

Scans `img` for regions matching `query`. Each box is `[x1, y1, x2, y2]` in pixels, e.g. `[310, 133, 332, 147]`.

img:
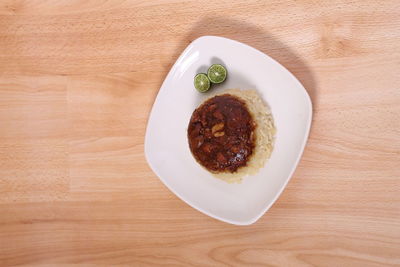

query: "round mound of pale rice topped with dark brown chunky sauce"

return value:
[188, 89, 275, 182]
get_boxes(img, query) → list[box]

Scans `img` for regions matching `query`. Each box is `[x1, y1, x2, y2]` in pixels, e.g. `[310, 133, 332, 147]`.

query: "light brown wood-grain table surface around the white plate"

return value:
[0, 0, 400, 266]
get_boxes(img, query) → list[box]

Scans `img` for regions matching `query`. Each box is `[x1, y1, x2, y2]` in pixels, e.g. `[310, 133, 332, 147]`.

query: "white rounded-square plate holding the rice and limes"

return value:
[145, 36, 312, 225]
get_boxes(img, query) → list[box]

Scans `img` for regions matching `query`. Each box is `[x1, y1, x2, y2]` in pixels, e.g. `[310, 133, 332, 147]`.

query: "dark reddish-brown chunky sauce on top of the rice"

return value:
[188, 94, 255, 173]
